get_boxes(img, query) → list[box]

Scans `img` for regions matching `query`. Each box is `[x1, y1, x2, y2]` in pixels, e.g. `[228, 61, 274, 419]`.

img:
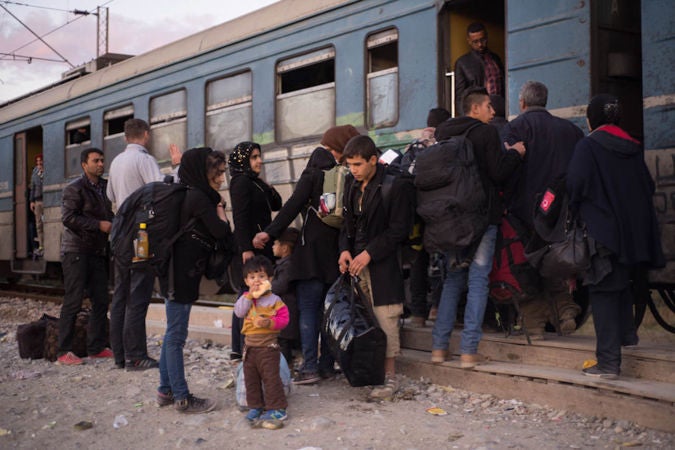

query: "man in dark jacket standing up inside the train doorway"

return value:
[455, 22, 505, 116]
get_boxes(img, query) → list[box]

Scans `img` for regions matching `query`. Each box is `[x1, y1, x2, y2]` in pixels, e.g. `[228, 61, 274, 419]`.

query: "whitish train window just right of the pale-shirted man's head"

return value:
[149, 89, 187, 162]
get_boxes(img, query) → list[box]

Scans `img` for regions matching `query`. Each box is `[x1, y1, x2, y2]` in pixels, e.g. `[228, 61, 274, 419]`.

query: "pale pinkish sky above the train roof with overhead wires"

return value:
[0, 0, 277, 103]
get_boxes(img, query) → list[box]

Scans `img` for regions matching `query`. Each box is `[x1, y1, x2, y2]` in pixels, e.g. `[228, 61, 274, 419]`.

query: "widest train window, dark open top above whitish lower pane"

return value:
[276, 48, 335, 141]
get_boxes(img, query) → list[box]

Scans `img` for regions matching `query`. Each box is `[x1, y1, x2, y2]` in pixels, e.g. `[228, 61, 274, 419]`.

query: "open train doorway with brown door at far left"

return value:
[13, 127, 44, 264]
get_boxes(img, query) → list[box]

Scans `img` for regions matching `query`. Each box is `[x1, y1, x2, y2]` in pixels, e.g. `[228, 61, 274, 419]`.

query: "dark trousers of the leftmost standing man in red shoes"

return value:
[59, 253, 108, 355]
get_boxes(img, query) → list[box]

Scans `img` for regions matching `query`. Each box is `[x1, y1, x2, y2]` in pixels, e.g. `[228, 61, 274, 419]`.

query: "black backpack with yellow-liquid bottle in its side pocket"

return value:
[110, 179, 191, 280]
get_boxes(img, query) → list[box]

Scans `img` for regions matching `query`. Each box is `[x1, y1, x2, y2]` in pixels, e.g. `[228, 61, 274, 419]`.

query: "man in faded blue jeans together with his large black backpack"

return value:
[426, 88, 525, 368]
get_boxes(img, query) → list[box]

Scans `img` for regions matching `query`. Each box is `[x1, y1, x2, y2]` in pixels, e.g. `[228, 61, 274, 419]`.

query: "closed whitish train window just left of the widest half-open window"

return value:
[206, 71, 253, 151]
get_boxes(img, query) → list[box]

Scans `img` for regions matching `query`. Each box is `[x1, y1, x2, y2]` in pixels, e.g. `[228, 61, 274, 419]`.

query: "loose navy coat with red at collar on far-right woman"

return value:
[567, 126, 665, 268]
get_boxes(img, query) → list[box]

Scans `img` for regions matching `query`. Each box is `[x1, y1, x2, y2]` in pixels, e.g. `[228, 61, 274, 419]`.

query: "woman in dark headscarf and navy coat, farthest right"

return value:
[567, 94, 665, 379]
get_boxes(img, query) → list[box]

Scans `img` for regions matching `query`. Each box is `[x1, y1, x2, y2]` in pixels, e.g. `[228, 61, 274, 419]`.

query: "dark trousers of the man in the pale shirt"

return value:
[110, 262, 155, 363]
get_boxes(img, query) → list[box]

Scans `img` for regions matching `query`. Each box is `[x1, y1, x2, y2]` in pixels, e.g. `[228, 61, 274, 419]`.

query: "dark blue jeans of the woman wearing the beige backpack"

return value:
[295, 279, 333, 373]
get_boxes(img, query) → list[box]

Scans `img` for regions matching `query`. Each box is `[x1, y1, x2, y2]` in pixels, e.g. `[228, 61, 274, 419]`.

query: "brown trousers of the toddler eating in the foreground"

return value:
[244, 347, 288, 410]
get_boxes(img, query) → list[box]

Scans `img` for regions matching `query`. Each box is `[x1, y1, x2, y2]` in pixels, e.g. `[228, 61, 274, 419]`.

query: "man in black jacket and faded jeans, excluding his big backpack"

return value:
[431, 88, 525, 368]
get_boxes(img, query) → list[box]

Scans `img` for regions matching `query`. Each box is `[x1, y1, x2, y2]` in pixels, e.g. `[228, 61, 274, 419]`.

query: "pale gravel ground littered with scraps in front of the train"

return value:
[0, 297, 675, 450]
